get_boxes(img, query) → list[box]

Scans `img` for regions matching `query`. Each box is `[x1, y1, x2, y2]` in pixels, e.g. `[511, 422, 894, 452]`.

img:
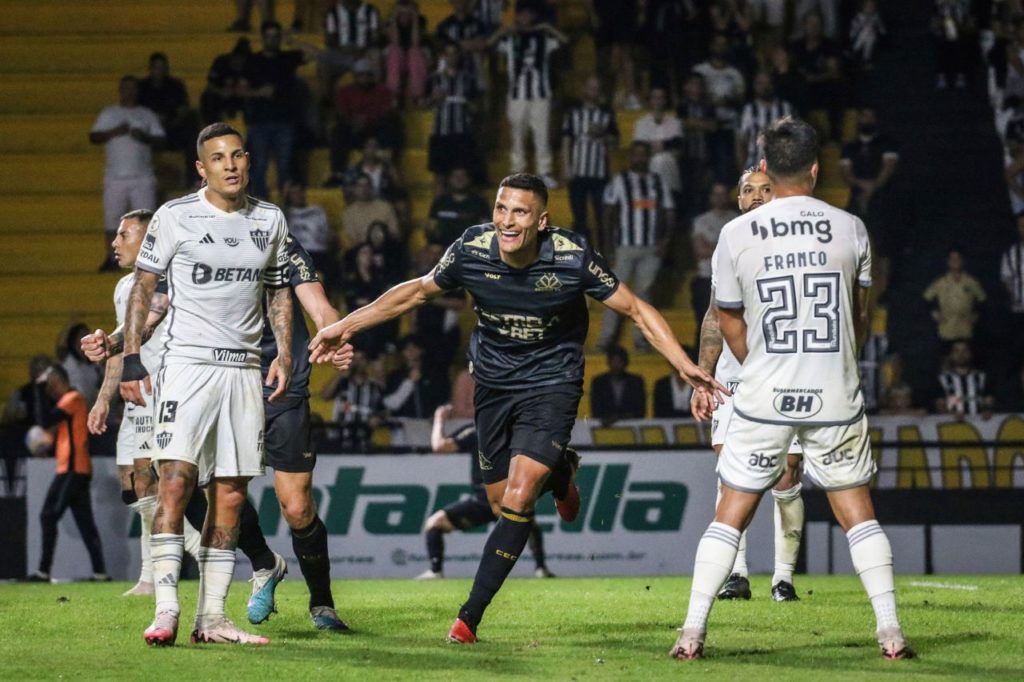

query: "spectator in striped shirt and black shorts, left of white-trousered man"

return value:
[426, 41, 485, 195]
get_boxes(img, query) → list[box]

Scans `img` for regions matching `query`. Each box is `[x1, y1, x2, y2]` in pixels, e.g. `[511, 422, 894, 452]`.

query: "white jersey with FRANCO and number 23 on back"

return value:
[715, 197, 871, 426]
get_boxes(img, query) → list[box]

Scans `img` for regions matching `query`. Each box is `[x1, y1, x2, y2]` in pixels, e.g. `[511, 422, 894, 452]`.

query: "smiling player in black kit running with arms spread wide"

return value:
[309, 173, 726, 644]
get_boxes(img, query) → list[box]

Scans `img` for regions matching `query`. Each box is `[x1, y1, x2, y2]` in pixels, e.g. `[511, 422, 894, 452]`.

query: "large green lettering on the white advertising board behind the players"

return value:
[249, 464, 688, 536]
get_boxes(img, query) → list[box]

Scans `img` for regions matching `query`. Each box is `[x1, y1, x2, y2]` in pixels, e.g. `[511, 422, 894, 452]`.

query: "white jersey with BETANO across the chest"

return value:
[136, 188, 288, 368]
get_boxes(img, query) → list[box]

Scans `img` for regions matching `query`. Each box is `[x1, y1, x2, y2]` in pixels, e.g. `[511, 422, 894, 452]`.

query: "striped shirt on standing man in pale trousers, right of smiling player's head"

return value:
[604, 171, 675, 247]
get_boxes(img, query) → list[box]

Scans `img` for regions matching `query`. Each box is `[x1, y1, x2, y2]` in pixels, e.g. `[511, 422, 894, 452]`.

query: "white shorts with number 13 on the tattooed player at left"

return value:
[153, 365, 263, 485]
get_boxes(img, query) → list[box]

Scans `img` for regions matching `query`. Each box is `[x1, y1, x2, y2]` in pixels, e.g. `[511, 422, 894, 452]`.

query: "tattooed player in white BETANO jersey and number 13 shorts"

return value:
[121, 123, 292, 644]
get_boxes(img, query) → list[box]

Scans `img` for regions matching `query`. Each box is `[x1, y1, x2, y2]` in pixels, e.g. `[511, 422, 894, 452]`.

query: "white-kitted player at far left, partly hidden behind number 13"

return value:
[82, 209, 200, 597]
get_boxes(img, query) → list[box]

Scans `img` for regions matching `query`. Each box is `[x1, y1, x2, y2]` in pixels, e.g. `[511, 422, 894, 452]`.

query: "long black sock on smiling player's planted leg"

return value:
[459, 507, 534, 633]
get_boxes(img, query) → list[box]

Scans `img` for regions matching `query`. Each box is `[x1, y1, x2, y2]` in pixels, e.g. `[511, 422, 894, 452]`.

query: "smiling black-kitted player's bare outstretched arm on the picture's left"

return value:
[309, 271, 442, 363]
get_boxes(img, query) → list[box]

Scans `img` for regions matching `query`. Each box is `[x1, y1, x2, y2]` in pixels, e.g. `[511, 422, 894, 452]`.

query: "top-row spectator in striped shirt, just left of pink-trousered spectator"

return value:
[316, 0, 381, 101]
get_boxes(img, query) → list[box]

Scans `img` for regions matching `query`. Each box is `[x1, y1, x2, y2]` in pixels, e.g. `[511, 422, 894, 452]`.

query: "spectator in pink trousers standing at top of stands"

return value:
[387, 0, 427, 102]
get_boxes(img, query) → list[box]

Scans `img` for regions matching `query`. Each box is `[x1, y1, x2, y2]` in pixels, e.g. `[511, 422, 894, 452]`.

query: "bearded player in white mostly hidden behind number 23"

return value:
[690, 168, 804, 601]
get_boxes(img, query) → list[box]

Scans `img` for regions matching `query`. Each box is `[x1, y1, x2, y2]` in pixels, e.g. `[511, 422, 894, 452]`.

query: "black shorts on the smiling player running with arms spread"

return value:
[473, 384, 583, 484]
